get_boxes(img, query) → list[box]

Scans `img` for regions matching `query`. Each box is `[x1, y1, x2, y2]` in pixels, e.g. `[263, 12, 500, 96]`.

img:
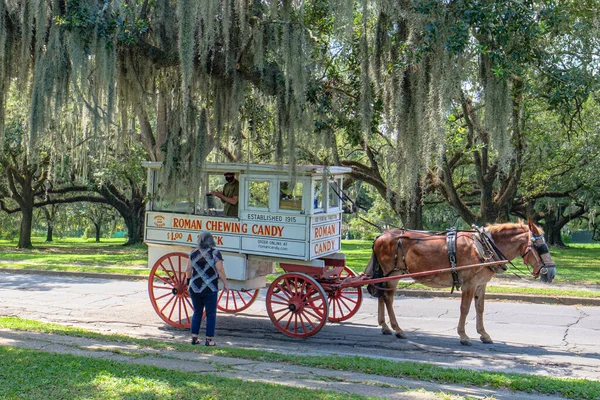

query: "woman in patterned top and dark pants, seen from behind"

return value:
[185, 231, 227, 346]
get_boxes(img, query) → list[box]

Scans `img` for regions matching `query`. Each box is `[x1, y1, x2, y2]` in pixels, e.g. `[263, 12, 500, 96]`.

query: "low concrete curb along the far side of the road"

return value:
[0, 268, 600, 307]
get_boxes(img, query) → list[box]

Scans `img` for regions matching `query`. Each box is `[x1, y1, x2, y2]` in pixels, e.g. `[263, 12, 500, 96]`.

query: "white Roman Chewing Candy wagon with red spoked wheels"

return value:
[144, 162, 362, 337]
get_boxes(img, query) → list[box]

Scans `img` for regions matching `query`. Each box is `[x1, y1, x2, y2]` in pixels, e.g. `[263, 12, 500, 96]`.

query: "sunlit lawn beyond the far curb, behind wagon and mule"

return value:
[0, 237, 600, 298]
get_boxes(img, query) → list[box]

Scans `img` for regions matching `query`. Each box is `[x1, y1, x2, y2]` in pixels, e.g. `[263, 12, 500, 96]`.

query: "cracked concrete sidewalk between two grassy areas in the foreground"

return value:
[0, 329, 561, 400]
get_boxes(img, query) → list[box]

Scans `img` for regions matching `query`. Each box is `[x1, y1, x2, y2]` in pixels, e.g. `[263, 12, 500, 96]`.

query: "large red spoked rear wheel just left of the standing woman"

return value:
[148, 253, 194, 328]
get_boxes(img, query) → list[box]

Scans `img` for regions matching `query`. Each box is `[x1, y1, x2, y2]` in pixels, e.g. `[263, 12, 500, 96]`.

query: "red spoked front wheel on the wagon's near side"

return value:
[266, 273, 328, 338]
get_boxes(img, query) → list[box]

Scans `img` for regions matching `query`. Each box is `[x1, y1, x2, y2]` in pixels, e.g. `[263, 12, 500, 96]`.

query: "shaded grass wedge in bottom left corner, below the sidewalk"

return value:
[0, 347, 366, 400]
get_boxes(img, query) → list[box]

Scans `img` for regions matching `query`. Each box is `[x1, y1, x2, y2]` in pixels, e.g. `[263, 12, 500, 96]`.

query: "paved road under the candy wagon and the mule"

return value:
[0, 273, 600, 380]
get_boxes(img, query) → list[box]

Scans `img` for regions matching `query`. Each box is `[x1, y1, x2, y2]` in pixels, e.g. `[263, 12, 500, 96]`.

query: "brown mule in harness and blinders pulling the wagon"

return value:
[365, 220, 556, 345]
